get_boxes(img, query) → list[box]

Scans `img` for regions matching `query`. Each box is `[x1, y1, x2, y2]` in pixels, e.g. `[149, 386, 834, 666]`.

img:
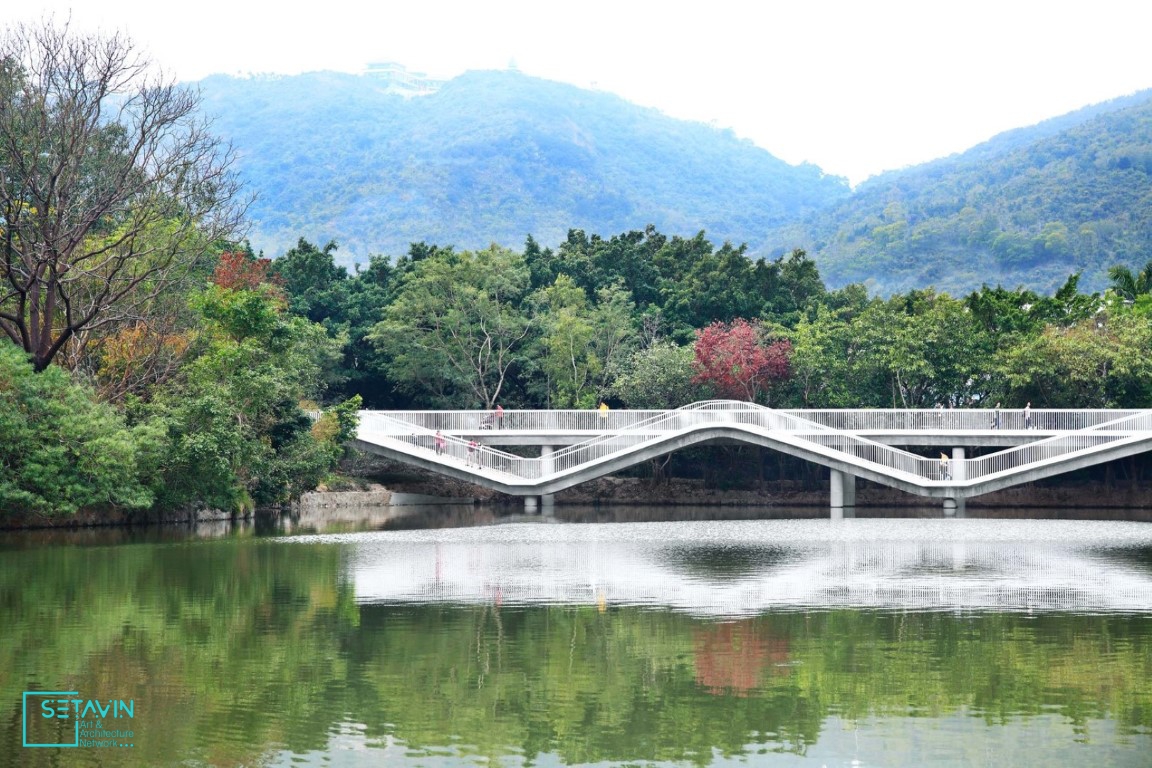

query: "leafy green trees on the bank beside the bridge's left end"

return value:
[151, 284, 345, 511]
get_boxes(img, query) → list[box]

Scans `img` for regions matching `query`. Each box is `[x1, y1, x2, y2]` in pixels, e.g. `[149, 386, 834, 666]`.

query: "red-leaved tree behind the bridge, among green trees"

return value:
[694, 319, 791, 403]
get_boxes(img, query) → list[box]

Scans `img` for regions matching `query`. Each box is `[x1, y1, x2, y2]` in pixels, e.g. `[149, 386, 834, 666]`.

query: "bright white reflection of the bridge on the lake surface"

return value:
[319, 519, 1152, 617]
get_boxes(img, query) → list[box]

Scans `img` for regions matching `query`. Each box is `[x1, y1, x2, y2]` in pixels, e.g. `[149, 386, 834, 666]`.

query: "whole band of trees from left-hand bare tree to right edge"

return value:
[0, 24, 1152, 517]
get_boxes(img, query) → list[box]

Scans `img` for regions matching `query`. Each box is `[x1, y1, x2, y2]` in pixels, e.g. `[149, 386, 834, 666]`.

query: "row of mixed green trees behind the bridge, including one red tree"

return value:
[270, 227, 1152, 408]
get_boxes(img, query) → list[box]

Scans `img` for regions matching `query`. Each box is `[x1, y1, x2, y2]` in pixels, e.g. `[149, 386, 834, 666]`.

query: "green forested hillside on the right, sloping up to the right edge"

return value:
[770, 91, 1152, 295]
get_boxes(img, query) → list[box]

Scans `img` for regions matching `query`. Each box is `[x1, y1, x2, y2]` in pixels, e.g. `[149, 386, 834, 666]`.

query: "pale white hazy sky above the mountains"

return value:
[11, 0, 1152, 183]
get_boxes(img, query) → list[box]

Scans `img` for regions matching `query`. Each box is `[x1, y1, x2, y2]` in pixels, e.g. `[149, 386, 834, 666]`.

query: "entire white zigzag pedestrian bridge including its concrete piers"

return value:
[354, 401, 1152, 515]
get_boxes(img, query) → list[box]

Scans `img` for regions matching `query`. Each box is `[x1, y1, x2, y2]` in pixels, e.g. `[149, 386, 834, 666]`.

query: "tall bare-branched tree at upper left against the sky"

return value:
[0, 22, 243, 371]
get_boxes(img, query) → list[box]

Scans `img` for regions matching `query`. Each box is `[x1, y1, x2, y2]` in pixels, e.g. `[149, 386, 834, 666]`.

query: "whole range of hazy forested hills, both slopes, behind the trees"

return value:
[199, 71, 1152, 295]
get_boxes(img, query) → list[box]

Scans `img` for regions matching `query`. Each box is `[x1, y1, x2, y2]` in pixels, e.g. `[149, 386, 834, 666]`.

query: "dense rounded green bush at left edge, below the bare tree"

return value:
[0, 343, 156, 515]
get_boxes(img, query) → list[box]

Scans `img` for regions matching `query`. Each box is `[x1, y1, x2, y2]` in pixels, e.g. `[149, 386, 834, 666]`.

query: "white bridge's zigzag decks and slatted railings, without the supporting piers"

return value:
[359, 401, 1152, 490]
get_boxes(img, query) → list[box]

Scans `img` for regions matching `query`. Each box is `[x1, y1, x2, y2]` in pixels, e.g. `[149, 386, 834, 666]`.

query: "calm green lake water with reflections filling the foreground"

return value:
[0, 507, 1152, 768]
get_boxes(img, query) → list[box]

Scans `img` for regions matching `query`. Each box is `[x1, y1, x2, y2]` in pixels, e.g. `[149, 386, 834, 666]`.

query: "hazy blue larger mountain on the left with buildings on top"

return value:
[197, 71, 850, 263]
